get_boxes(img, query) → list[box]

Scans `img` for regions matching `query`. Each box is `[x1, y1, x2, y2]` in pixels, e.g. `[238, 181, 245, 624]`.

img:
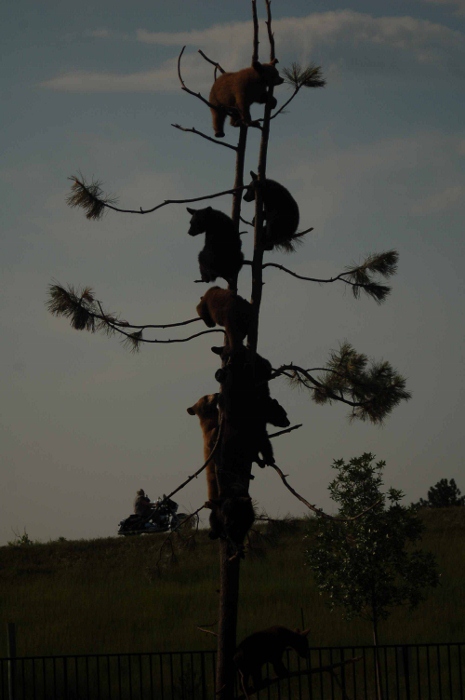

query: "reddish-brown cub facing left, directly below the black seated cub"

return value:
[197, 287, 252, 354]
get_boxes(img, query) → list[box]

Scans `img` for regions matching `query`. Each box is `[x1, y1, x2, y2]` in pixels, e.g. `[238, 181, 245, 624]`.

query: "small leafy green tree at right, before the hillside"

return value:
[306, 452, 439, 698]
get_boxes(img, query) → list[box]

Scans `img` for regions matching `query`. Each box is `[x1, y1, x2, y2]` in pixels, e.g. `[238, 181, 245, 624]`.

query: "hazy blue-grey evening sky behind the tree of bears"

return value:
[0, 0, 465, 544]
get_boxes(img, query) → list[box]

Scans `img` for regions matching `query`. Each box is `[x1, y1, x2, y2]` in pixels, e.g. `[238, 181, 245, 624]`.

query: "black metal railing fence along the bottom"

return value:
[0, 643, 465, 700]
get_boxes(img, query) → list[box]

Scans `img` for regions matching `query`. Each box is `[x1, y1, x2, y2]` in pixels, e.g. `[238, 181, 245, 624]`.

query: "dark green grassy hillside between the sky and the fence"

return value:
[0, 508, 465, 656]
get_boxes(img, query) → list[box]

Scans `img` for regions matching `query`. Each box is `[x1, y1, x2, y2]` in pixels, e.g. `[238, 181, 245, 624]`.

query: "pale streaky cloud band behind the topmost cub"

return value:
[42, 10, 465, 92]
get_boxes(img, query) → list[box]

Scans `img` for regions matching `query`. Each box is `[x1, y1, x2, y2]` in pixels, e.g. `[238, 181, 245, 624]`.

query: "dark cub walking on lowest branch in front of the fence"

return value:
[234, 625, 310, 697]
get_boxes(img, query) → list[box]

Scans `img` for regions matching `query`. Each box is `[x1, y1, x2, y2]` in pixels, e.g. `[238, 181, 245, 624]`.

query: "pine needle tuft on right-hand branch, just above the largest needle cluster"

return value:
[343, 250, 399, 304]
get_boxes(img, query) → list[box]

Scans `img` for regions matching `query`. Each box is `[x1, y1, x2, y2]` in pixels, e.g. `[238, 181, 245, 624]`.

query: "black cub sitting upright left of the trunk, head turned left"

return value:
[187, 207, 244, 287]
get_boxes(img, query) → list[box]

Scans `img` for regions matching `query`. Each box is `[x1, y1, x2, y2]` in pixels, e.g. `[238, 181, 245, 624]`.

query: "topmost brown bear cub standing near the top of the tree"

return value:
[209, 58, 284, 138]
